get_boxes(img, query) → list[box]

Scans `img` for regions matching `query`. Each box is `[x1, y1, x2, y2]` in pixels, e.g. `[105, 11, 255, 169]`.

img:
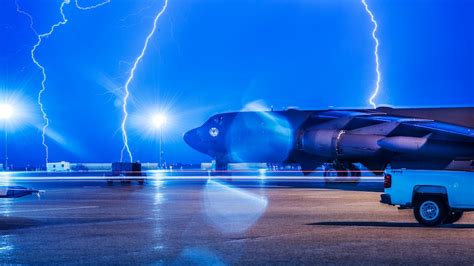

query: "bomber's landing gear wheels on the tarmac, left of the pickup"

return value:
[324, 163, 361, 184]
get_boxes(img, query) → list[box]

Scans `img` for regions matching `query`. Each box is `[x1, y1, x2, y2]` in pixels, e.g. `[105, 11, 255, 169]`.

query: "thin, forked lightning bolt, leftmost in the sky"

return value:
[15, 0, 110, 164]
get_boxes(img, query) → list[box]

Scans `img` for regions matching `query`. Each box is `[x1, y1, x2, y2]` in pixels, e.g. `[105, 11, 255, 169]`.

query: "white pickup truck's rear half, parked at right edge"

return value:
[380, 169, 474, 226]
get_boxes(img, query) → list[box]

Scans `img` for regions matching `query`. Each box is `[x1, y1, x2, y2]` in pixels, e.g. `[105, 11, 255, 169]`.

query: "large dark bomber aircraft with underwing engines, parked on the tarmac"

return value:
[184, 107, 474, 176]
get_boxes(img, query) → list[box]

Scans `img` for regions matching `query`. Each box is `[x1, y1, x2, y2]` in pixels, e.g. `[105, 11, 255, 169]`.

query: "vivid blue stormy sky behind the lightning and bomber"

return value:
[0, 0, 474, 165]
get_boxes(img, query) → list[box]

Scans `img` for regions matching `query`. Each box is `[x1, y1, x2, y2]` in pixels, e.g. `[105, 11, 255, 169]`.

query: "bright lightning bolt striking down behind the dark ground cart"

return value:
[120, 0, 168, 162]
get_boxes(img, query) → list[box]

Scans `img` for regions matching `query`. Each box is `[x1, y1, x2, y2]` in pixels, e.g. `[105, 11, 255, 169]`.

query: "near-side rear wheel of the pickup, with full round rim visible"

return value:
[414, 197, 448, 226]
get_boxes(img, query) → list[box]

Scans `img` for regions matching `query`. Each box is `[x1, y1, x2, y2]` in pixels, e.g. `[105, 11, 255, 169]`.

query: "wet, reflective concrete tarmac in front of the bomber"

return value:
[0, 177, 474, 265]
